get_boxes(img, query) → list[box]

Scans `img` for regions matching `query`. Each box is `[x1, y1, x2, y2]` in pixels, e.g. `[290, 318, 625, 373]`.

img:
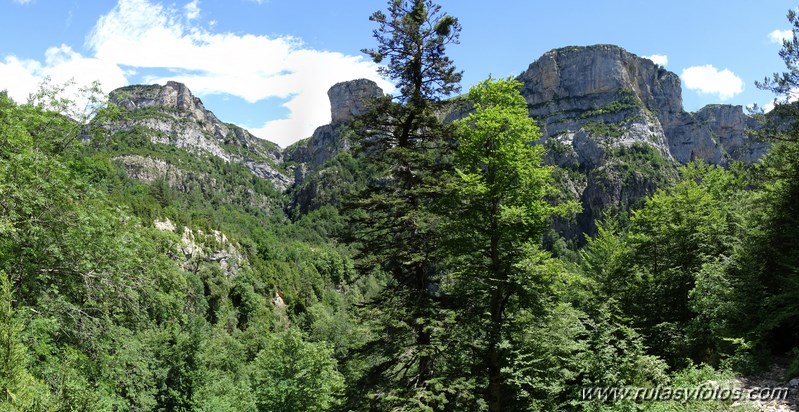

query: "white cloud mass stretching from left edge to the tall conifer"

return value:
[0, 0, 393, 146]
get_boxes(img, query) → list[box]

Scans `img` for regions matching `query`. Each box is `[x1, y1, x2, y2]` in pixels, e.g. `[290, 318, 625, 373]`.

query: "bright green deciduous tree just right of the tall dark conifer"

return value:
[449, 79, 577, 411]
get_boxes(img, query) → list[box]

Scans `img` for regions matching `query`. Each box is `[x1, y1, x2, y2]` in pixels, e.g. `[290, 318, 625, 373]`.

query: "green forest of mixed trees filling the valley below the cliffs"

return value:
[0, 0, 799, 412]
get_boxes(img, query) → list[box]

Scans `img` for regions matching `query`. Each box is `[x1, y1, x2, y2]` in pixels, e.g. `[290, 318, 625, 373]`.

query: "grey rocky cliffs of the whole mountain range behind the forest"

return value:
[101, 45, 768, 241]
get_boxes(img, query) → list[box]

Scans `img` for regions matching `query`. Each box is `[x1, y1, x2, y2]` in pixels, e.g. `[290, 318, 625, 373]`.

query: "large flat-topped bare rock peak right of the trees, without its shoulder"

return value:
[519, 45, 682, 169]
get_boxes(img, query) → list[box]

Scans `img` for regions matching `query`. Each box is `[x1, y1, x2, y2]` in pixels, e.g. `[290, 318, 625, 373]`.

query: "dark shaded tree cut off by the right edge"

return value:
[743, 5, 799, 365]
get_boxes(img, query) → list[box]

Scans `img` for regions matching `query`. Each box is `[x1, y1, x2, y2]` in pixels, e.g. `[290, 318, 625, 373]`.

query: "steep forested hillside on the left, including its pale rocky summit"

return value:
[0, 83, 379, 411]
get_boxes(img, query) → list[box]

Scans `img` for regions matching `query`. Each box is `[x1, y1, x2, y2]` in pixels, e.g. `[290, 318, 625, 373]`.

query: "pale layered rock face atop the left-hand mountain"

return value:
[110, 82, 293, 191]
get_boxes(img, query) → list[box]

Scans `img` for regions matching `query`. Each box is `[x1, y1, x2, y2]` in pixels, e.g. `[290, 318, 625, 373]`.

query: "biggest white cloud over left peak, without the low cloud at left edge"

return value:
[87, 0, 393, 146]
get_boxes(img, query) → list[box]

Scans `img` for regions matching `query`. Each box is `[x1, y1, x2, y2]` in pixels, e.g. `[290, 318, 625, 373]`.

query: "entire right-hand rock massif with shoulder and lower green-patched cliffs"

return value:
[518, 45, 768, 237]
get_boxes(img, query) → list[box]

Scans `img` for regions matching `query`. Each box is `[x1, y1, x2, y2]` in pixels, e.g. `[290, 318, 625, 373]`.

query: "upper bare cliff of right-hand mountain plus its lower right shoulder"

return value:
[519, 45, 766, 164]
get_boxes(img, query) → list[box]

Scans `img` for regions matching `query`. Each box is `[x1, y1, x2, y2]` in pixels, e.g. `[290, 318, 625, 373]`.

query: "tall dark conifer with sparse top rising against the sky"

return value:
[350, 0, 461, 409]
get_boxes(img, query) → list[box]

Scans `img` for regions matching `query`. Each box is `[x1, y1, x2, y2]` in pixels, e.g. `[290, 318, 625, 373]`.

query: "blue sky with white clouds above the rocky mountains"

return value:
[0, 0, 796, 146]
